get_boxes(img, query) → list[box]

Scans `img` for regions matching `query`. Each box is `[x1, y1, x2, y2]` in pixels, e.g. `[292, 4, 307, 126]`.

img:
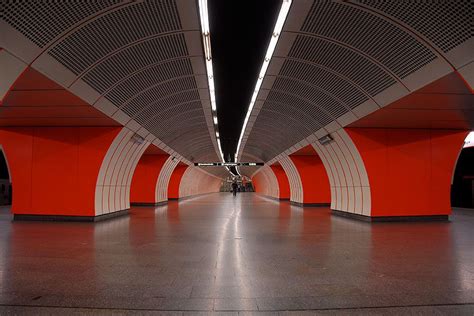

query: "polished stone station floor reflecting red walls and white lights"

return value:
[0, 193, 474, 315]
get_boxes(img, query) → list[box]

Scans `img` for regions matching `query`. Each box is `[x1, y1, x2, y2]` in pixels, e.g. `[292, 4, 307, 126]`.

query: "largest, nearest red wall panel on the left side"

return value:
[0, 127, 120, 216]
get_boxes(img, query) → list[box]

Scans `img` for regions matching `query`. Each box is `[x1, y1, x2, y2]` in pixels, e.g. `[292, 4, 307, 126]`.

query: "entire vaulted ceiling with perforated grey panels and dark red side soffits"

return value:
[0, 0, 474, 177]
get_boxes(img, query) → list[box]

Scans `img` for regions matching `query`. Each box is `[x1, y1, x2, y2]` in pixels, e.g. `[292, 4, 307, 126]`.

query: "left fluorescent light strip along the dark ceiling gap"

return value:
[199, 0, 225, 162]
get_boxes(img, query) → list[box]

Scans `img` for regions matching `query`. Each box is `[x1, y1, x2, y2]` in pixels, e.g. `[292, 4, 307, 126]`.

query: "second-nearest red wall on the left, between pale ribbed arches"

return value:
[130, 155, 169, 204]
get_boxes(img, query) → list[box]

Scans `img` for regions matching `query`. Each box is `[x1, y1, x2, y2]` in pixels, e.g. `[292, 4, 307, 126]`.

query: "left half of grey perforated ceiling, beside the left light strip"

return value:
[5, 0, 221, 167]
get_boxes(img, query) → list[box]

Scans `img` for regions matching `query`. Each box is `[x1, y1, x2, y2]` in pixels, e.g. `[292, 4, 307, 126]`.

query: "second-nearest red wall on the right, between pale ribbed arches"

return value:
[289, 154, 331, 204]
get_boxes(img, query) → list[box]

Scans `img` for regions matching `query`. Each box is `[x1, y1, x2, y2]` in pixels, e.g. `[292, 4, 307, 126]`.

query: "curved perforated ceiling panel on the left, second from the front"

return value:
[49, 0, 181, 73]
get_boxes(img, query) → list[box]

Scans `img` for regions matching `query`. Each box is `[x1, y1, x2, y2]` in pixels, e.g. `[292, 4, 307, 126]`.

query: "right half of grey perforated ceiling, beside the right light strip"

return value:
[243, 0, 473, 161]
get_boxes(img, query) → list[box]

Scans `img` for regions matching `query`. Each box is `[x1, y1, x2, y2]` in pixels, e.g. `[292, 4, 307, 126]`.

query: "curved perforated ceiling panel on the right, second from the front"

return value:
[301, 1, 436, 77]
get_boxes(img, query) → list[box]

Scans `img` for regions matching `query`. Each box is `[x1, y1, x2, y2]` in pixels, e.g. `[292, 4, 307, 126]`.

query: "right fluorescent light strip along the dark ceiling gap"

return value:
[235, 0, 292, 160]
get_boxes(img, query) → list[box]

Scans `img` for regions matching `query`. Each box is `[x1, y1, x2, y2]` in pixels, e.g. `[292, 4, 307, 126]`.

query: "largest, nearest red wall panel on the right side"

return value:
[346, 128, 468, 216]
